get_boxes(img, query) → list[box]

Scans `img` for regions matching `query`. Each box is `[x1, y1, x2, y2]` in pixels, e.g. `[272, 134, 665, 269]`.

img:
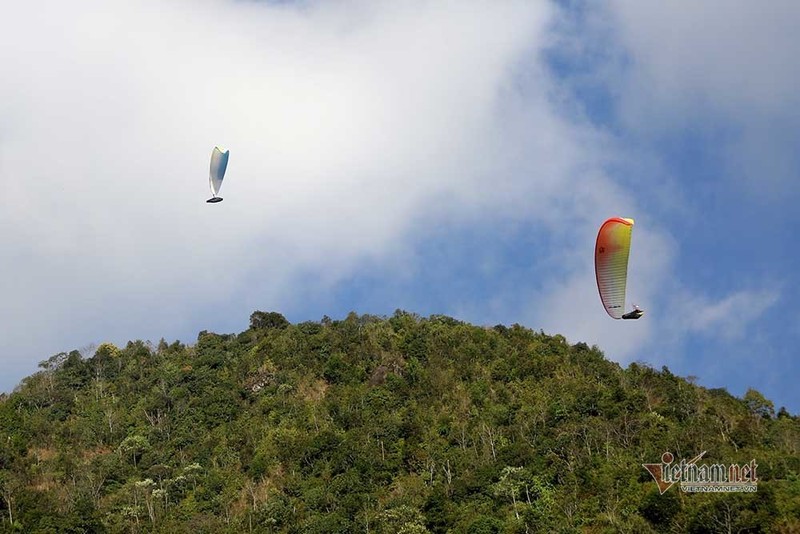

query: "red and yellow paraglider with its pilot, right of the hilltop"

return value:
[594, 217, 644, 319]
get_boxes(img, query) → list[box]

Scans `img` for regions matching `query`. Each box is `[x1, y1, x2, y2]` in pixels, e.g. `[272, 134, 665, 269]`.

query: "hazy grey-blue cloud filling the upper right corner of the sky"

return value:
[598, 0, 800, 201]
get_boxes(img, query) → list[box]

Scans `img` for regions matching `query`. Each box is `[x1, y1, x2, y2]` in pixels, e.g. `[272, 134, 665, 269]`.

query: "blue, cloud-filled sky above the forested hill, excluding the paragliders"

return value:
[0, 0, 800, 414]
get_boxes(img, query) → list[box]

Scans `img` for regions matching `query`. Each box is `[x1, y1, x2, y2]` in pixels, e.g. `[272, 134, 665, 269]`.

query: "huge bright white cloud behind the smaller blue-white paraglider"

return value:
[0, 0, 586, 387]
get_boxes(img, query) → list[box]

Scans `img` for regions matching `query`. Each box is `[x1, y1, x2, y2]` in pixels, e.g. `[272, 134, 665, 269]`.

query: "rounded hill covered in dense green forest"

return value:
[0, 311, 800, 534]
